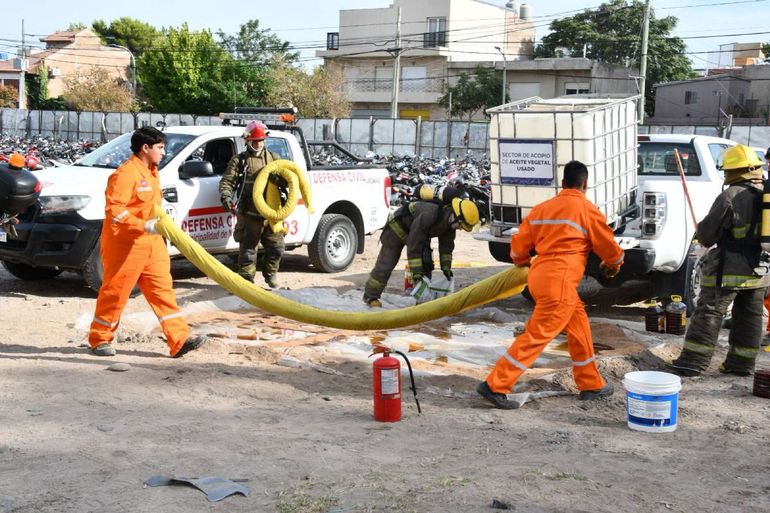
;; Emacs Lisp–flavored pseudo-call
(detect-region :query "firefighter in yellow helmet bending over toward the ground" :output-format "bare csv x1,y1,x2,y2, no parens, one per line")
364,198,479,307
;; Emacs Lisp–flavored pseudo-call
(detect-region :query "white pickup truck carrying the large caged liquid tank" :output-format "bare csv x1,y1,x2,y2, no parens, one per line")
476,134,736,312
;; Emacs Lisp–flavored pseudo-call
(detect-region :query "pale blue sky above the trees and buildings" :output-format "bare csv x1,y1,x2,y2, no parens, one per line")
0,0,770,68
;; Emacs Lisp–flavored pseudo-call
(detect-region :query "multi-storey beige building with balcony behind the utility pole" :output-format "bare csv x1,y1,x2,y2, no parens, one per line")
317,0,535,119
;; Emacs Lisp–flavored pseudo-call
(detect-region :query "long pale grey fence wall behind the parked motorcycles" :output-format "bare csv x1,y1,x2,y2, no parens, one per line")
0,109,770,158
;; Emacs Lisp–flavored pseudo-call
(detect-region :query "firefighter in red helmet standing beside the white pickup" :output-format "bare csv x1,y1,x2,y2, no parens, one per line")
219,121,288,288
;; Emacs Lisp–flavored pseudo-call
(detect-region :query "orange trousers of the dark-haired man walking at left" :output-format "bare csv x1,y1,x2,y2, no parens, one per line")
88,235,190,356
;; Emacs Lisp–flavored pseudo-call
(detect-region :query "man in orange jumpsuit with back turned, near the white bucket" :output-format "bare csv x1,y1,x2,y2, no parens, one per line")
476,161,624,410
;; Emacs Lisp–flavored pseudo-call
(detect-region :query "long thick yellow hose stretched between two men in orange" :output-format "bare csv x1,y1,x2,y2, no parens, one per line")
155,206,528,330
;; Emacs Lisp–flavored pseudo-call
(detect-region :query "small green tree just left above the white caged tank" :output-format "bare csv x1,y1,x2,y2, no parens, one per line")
439,65,503,121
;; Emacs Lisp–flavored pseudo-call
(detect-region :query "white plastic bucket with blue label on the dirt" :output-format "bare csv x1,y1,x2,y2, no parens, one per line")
623,371,682,433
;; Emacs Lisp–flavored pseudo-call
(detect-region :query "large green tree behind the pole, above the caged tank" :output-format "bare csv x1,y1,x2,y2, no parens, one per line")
535,0,694,113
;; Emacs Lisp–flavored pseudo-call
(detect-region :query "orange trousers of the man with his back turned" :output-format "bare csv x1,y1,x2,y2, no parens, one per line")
487,254,605,394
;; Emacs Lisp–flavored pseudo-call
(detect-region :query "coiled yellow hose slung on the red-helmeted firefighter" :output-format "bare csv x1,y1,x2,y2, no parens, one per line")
252,159,313,233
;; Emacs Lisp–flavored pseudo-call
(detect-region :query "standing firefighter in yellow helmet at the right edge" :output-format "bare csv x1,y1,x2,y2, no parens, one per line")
671,144,770,376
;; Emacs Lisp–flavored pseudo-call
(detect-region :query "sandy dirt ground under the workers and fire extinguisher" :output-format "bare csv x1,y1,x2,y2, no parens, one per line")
0,234,770,513
